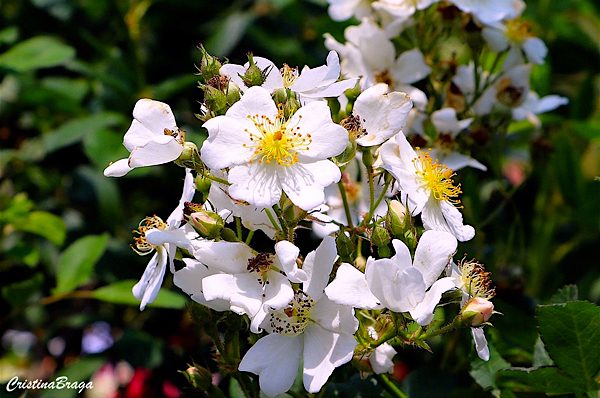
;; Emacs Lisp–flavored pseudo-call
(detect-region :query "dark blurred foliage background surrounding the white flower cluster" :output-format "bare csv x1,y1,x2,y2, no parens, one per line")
0,0,600,397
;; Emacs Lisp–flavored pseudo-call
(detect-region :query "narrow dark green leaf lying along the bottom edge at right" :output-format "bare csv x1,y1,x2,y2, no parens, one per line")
496,367,585,394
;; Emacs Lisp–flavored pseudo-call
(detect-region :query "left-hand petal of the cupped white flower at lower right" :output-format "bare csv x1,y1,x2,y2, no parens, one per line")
325,263,381,309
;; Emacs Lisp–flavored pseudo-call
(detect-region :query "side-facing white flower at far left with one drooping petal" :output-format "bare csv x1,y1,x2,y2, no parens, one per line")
104,99,185,177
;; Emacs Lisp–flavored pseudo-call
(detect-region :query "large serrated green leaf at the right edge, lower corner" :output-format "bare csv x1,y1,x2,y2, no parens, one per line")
537,301,600,391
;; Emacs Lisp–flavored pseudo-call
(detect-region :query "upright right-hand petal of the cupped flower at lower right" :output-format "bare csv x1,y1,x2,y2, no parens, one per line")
413,230,458,287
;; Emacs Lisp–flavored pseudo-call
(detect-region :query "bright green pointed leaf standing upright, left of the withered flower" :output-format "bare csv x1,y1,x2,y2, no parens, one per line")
53,234,108,294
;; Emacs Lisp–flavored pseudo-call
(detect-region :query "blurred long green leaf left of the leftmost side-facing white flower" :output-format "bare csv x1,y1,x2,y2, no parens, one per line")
42,112,125,153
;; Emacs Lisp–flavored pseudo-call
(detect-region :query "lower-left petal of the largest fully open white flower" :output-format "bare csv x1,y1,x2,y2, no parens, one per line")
228,162,282,207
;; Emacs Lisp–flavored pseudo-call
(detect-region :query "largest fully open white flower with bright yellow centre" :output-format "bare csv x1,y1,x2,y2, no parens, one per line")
201,87,348,210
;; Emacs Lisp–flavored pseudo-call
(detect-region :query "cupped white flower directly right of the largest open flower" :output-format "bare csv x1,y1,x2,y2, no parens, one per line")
352,83,412,146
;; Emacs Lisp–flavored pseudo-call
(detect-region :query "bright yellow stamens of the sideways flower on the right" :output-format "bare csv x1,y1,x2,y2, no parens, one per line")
413,149,462,205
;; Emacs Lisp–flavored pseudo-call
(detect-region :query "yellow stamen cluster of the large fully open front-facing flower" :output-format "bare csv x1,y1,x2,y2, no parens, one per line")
244,114,312,166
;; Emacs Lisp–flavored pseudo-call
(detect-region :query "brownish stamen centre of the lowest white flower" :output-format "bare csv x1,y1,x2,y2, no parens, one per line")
269,291,315,336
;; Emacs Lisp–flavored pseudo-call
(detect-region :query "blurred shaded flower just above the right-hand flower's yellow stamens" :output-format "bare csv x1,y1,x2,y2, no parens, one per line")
431,108,487,171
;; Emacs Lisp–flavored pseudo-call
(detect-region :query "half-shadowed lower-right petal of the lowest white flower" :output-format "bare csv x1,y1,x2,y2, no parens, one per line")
304,326,356,393
